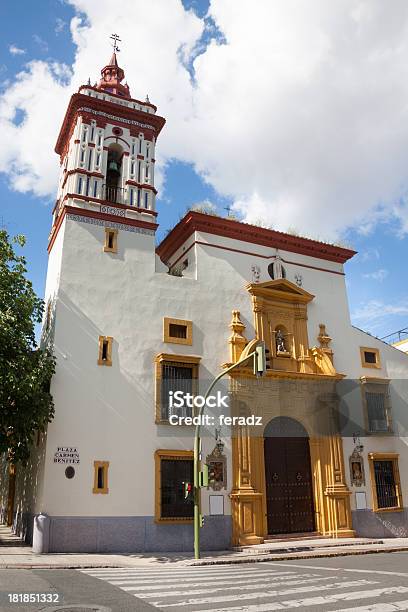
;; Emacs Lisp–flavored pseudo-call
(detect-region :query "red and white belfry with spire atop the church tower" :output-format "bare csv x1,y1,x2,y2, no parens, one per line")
48,34,165,251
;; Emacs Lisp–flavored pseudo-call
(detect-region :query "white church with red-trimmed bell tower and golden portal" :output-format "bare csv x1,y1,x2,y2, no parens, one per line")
1,49,408,552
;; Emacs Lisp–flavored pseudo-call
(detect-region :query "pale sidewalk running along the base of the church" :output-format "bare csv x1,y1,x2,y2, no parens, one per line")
0,526,408,569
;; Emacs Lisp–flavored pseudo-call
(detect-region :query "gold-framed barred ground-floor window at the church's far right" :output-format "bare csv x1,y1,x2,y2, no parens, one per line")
368,453,404,512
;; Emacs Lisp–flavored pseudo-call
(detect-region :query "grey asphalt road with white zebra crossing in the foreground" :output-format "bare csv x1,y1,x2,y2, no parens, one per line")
0,553,408,612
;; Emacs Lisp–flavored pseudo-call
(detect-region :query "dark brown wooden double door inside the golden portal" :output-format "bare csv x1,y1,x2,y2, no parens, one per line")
264,436,315,535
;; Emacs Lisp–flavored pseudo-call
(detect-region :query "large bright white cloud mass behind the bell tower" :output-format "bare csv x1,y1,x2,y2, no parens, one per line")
0,0,408,239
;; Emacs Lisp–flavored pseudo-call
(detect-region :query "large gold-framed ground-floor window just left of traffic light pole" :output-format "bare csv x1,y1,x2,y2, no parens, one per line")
154,449,194,523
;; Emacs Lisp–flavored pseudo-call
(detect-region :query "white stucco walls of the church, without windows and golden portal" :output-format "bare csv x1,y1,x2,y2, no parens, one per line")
3,52,408,551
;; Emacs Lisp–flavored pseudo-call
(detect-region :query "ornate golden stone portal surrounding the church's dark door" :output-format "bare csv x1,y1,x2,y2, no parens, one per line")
229,279,355,545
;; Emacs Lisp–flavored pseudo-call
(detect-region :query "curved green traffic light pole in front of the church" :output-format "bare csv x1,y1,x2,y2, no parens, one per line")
194,340,266,559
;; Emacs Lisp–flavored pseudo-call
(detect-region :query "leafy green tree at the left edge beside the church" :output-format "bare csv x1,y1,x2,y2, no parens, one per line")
0,230,55,465
